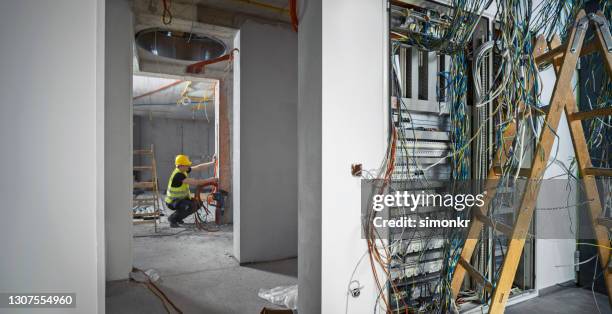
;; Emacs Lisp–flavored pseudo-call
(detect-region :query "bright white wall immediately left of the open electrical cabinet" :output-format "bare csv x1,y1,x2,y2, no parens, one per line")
320,0,388,313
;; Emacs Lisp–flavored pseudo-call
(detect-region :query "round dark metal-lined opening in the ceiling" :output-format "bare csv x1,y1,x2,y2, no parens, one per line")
136,28,227,62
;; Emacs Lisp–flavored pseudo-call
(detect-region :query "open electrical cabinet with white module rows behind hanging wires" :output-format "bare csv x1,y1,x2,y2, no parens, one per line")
388,1,491,312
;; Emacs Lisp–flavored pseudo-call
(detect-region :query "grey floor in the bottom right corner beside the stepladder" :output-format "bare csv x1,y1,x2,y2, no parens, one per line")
506,287,612,314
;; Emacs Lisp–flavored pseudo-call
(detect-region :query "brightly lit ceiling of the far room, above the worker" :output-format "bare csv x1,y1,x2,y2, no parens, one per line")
132,75,217,122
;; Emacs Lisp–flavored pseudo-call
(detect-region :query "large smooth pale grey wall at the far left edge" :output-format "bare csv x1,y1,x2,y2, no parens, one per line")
0,0,105,313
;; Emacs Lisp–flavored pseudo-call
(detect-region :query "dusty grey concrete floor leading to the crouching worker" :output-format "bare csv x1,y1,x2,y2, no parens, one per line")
106,219,297,314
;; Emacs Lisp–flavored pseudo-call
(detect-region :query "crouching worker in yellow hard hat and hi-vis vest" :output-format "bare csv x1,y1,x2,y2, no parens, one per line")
165,155,217,228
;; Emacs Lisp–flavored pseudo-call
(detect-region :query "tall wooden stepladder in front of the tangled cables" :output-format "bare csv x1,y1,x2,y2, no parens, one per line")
451,10,612,314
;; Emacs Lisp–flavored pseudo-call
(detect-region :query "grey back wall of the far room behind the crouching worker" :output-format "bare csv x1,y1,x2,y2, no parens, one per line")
134,116,215,189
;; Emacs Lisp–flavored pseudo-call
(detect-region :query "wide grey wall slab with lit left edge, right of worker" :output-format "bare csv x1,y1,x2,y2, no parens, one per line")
233,21,297,263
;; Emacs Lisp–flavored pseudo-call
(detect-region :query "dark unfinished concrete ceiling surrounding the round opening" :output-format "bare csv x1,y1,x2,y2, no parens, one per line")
133,0,290,79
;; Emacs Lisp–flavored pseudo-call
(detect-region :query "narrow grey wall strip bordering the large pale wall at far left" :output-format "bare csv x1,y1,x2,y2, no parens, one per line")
104,0,133,280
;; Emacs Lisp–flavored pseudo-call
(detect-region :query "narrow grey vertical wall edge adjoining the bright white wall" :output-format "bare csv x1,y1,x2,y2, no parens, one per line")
297,0,323,313
